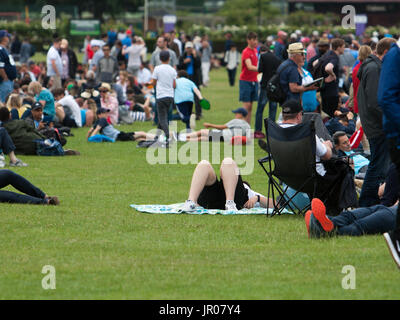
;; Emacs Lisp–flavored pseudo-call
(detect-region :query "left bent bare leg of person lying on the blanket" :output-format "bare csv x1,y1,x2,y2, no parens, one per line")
188,160,217,203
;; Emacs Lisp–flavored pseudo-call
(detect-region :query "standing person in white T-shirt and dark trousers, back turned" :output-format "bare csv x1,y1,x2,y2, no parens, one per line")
149,50,177,145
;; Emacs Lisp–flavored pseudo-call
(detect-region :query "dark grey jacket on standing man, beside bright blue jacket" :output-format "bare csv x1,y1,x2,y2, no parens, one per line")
357,54,384,139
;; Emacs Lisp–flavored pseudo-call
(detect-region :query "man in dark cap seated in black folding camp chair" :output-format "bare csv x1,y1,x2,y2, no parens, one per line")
259,100,355,215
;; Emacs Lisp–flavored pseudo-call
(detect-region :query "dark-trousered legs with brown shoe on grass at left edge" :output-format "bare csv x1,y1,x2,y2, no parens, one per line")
0,169,60,205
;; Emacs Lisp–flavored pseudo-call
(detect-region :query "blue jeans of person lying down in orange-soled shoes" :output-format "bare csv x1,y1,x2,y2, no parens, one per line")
329,205,397,236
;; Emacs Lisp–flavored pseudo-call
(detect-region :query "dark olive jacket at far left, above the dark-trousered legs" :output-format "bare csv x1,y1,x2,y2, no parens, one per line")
3,120,46,155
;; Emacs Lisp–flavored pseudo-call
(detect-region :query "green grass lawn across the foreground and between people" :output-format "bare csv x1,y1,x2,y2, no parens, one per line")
0,65,400,299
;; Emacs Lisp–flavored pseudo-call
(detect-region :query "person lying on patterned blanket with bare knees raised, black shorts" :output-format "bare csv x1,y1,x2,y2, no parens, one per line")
182,158,271,212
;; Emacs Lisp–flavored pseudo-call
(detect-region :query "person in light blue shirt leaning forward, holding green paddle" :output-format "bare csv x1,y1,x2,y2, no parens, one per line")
174,70,203,130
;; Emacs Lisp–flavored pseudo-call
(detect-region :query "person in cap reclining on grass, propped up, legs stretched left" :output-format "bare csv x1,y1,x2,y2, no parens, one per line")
178,108,251,141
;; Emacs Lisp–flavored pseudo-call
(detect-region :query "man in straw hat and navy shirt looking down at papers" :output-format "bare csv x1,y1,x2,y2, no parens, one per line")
274,42,318,104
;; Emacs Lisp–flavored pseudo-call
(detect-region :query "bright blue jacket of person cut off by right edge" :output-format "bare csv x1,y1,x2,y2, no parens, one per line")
378,43,400,146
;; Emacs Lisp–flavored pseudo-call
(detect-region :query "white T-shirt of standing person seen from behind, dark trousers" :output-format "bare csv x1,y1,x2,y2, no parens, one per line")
152,64,177,99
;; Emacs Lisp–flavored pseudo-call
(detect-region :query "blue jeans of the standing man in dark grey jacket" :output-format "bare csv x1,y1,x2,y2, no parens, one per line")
359,135,390,207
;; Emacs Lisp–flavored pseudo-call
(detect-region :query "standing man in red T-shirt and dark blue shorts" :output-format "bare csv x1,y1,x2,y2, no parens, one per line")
239,32,258,124
